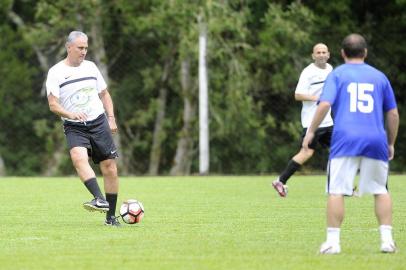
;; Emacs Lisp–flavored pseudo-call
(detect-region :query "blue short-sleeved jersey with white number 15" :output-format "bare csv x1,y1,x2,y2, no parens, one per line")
320,63,396,161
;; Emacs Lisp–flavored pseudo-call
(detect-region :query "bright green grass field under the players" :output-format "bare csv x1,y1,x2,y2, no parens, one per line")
0,176,406,270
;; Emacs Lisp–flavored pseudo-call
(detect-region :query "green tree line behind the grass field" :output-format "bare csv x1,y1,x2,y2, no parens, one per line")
0,0,406,176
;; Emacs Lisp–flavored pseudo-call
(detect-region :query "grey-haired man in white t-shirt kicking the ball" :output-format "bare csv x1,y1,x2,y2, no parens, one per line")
46,31,120,226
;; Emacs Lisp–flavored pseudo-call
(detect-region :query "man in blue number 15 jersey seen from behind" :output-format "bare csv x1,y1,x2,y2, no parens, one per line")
303,34,399,254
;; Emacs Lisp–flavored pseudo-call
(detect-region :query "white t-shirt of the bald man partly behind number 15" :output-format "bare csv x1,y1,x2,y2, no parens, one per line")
295,63,333,128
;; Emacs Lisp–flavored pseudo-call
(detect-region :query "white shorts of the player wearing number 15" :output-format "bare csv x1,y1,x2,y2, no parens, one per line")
326,157,389,196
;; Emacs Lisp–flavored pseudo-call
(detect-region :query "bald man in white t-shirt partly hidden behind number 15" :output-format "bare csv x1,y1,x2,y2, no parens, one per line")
272,43,333,197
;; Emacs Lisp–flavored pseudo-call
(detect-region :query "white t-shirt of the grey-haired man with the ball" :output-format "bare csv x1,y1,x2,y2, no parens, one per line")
46,60,107,122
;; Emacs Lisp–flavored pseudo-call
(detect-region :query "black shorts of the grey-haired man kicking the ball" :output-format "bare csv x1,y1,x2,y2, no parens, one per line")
63,114,118,164
